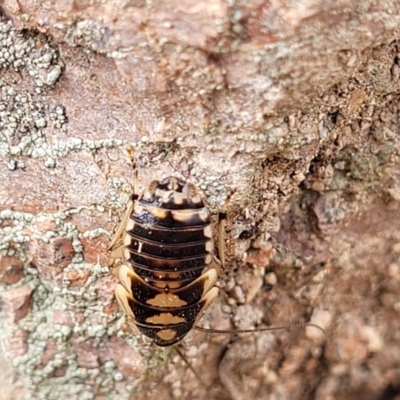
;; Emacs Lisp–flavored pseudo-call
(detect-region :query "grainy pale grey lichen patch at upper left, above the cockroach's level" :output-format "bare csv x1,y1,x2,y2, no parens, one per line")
0,19,136,170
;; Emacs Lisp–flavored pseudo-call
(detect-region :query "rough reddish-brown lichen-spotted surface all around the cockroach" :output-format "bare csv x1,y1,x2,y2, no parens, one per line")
0,0,400,400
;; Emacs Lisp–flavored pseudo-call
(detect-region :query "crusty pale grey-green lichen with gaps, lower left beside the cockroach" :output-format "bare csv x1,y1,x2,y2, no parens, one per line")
0,206,155,399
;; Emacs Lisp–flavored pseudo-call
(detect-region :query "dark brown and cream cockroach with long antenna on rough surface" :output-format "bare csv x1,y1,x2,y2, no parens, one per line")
108,177,322,346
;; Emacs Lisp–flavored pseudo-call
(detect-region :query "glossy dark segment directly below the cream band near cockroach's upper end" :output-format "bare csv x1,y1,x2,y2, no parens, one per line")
127,224,208,244
